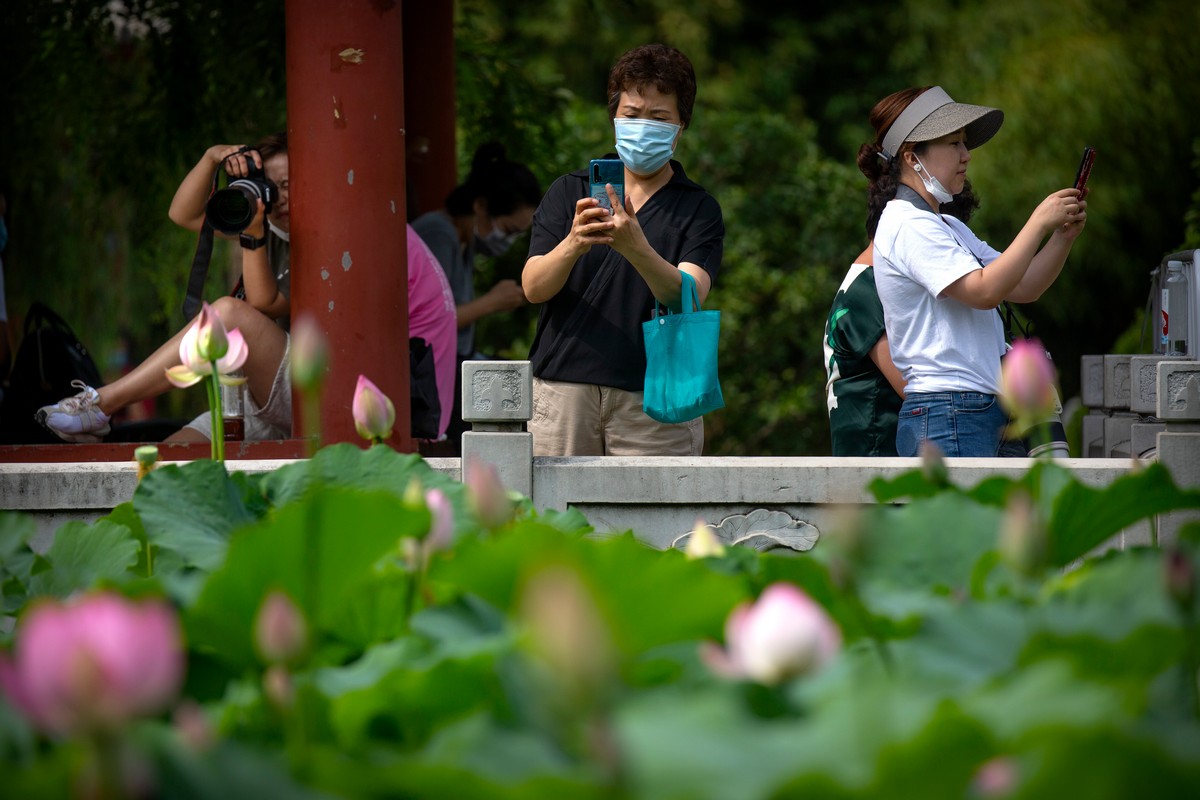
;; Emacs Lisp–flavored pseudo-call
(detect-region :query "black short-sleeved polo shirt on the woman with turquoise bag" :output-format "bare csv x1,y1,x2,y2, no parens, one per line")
529,155,725,392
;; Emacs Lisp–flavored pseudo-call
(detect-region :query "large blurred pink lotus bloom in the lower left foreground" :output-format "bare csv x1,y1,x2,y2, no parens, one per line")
0,594,184,735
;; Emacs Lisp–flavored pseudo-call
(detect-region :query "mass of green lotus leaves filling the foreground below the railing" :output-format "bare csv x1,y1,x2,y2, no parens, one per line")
7,444,1200,800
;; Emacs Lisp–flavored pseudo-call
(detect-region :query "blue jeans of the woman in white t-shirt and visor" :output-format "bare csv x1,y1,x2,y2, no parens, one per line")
896,392,1008,458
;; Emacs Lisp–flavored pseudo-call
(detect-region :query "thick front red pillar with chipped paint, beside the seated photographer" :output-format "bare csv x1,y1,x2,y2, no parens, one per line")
286,0,416,451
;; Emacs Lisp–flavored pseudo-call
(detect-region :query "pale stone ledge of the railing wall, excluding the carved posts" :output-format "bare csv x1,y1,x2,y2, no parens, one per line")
0,455,1146,556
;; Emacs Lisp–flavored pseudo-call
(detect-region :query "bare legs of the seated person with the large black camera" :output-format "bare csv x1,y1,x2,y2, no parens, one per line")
97,296,287,416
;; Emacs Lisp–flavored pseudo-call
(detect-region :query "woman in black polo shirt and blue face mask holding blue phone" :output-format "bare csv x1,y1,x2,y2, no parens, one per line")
521,44,725,456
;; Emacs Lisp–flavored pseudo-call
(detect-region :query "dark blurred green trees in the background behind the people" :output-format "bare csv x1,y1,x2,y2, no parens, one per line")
0,0,1200,455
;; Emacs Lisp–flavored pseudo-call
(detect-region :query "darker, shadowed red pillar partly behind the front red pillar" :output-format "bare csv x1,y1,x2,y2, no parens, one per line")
404,0,458,217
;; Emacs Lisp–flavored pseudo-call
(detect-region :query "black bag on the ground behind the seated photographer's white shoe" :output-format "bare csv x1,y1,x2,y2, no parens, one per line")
0,302,101,444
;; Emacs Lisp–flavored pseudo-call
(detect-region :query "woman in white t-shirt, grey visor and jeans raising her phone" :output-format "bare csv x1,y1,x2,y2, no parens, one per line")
859,86,1087,457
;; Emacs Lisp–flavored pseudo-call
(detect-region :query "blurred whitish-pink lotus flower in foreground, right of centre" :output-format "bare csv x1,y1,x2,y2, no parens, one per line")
701,583,841,685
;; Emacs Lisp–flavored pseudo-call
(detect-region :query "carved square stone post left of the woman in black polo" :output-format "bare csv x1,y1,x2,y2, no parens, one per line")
461,361,533,497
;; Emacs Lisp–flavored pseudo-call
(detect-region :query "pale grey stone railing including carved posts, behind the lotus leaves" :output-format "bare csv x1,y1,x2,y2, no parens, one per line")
0,361,1200,551
